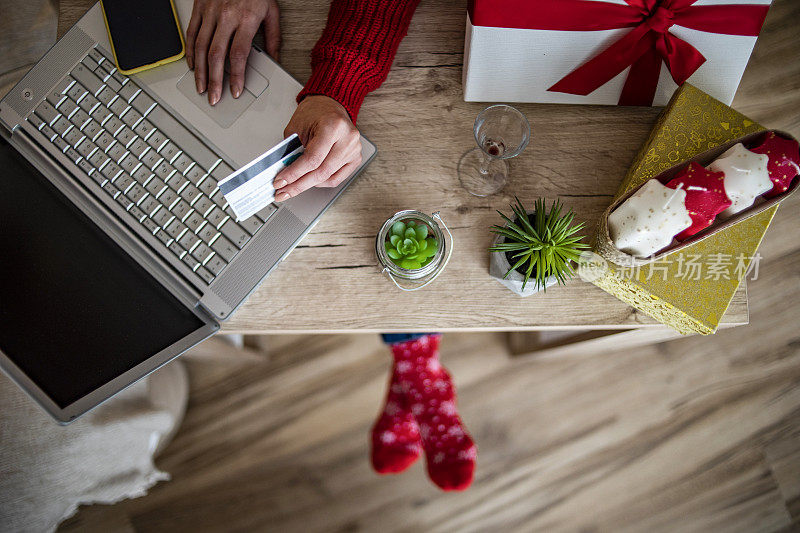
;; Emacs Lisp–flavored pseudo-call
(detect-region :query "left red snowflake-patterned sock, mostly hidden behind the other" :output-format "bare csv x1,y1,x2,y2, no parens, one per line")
371,364,422,474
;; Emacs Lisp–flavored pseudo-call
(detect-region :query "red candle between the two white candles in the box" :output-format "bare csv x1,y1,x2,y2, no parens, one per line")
667,162,731,241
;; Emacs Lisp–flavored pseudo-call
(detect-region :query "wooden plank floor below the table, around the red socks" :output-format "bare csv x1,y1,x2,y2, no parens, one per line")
64,189,800,532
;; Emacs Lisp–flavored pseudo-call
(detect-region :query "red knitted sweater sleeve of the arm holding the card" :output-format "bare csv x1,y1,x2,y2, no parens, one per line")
297,0,419,122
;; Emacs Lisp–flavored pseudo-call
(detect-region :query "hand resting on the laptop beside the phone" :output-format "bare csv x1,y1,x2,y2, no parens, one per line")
186,0,281,105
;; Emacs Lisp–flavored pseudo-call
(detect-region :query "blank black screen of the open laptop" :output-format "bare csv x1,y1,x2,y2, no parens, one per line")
0,140,204,408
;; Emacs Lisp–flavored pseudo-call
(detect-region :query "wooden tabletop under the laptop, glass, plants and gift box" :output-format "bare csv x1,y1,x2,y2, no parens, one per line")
59,0,800,333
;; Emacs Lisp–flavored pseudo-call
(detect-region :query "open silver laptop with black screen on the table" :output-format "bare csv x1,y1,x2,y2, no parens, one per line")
0,0,376,423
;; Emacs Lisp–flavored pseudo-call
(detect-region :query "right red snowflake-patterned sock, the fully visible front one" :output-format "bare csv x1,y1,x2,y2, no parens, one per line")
392,335,477,490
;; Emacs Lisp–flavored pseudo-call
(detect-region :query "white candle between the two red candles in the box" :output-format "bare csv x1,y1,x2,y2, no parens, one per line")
708,143,772,217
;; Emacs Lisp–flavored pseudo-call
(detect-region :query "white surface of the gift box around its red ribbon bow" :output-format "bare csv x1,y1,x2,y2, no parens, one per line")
463,0,771,106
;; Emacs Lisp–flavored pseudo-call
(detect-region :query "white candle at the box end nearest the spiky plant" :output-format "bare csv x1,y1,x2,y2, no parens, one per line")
608,179,692,257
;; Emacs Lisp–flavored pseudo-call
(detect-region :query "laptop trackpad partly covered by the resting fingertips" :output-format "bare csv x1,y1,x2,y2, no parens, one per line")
178,67,269,128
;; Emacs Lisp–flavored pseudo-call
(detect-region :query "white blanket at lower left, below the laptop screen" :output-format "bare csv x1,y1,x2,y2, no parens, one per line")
0,361,187,532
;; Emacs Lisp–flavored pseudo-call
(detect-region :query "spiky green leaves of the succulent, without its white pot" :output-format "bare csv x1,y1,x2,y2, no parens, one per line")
489,198,588,290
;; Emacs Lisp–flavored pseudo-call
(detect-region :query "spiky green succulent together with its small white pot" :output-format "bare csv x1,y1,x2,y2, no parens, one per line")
489,198,588,296
